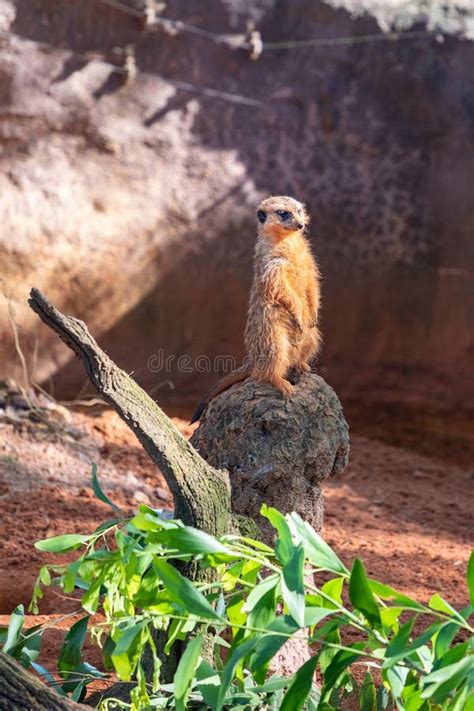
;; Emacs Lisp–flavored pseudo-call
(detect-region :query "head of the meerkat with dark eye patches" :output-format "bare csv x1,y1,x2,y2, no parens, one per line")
257,195,309,242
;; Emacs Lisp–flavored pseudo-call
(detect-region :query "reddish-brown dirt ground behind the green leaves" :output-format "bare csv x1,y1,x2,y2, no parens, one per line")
0,392,474,692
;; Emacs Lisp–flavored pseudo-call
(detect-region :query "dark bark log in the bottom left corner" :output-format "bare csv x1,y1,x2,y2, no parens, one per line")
0,652,92,711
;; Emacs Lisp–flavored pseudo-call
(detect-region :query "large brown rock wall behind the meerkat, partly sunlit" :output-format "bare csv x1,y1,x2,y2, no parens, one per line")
0,0,474,408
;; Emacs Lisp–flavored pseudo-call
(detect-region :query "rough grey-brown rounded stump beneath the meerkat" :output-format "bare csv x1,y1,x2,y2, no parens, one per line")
191,373,349,544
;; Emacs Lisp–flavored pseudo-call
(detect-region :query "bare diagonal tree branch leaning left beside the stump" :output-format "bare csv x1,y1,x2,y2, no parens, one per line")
28,289,231,536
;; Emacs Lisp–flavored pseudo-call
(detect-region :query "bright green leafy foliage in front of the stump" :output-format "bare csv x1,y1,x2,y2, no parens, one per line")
3,471,474,711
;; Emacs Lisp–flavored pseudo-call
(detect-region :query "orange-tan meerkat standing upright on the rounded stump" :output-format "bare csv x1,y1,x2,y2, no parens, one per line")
191,196,321,422
